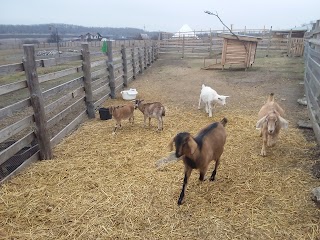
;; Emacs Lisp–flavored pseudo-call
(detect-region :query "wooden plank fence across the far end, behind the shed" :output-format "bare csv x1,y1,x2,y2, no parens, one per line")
159,29,304,58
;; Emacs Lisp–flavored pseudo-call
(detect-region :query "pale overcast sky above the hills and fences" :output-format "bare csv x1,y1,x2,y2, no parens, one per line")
0,0,320,32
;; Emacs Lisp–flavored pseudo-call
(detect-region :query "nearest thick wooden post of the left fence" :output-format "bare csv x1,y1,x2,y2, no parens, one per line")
23,44,53,160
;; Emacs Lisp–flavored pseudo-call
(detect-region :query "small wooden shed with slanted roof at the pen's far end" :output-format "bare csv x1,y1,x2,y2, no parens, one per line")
219,34,261,69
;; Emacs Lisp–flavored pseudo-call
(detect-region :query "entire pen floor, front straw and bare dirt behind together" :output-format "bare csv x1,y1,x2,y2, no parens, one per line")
0,27,320,239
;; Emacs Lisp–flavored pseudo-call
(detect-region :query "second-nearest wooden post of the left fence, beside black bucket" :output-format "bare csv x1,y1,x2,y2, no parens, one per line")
81,43,96,118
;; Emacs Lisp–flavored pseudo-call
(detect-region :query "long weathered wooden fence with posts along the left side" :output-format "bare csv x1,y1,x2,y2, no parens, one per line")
0,41,158,183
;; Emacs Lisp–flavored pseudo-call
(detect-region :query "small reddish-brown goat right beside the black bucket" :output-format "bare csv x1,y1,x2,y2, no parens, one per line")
109,103,134,134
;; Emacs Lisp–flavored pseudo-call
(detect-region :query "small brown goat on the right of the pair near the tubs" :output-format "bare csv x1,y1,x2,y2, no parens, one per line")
135,99,166,131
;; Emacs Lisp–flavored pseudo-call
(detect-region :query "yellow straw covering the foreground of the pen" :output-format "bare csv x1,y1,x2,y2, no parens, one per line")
0,105,320,240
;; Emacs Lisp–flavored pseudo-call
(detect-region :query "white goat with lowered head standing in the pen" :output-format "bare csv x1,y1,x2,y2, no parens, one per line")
198,84,229,117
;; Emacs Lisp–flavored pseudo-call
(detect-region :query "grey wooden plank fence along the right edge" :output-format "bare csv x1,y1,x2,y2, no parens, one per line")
304,20,320,144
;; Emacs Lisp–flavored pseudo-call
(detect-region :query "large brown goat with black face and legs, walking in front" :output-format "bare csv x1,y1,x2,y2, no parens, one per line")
169,118,227,205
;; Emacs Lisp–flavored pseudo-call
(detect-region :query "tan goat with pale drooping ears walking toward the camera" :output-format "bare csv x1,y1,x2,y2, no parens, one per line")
256,93,288,156
